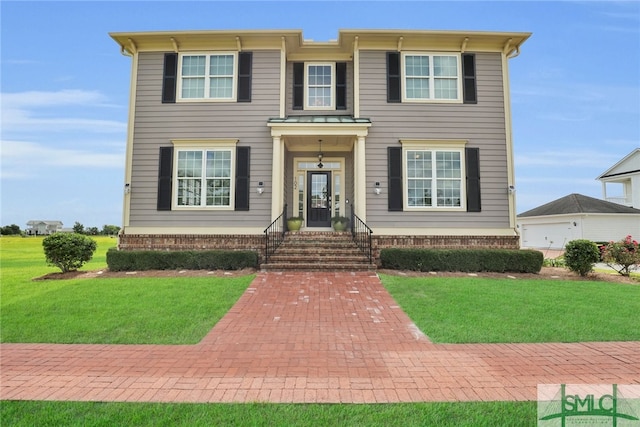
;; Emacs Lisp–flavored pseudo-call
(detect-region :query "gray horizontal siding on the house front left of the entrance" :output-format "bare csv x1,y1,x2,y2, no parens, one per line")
130,51,280,227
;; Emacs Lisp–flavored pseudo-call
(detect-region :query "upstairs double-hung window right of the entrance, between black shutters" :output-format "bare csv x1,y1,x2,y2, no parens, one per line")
402,53,462,102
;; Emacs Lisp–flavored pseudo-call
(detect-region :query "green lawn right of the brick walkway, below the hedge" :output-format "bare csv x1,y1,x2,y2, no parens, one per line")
380,275,640,343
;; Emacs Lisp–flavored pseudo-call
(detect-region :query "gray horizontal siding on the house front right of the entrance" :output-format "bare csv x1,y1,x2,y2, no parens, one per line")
360,51,509,231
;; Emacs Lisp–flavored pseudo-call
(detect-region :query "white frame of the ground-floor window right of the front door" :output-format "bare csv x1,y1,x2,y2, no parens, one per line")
400,140,467,212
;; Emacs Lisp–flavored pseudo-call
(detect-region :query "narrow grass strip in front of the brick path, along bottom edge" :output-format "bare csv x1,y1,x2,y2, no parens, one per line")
0,401,537,427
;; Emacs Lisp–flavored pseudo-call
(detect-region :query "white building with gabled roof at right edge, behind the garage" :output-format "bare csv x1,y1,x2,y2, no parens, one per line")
597,148,640,209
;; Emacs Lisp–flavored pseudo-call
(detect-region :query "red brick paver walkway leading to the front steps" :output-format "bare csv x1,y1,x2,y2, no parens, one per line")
0,273,640,403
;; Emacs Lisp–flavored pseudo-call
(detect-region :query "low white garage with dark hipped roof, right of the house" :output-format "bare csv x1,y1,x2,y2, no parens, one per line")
518,194,640,249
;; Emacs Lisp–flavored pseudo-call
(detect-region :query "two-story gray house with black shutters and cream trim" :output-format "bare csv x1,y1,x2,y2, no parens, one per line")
111,30,530,262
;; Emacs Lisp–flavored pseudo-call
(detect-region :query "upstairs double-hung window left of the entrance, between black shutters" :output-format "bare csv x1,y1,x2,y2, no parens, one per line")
178,53,237,101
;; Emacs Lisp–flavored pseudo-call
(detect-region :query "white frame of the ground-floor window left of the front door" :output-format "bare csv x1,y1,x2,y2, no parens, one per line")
171,139,238,211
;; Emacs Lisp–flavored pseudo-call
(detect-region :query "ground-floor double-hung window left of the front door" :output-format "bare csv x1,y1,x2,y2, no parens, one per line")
176,148,233,208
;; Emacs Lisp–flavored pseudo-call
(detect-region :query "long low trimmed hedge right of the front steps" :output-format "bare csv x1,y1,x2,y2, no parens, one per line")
380,248,544,273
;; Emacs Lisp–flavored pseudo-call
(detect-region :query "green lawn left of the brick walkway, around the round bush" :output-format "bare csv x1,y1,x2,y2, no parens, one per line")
0,237,253,344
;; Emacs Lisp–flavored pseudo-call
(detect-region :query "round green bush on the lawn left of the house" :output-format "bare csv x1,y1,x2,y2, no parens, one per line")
42,233,98,273
